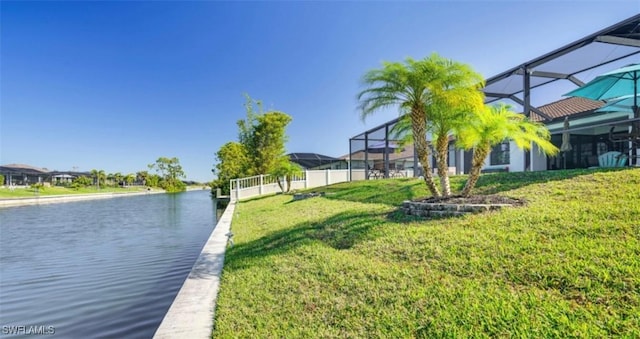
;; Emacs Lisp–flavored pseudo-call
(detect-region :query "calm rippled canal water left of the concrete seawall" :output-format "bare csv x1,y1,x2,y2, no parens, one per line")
0,191,216,338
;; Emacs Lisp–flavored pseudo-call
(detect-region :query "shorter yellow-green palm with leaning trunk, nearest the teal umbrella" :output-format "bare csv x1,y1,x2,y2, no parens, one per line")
457,104,558,197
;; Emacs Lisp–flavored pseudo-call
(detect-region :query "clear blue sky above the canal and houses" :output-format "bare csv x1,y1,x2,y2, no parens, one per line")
0,0,640,181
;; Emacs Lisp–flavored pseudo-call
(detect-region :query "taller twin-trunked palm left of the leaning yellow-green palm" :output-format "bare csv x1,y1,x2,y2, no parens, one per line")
358,53,483,196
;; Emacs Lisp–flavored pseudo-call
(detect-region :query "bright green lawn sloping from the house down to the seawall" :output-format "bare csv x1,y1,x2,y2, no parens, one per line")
213,169,640,338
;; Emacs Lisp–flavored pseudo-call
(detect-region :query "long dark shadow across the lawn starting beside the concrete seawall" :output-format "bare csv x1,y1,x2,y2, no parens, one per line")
225,211,385,269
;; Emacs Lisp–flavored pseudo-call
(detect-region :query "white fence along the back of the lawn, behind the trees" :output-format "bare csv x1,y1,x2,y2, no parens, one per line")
230,169,350,201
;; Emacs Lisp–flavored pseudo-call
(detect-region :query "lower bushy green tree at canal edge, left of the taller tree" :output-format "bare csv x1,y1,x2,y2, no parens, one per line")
211,141,253,194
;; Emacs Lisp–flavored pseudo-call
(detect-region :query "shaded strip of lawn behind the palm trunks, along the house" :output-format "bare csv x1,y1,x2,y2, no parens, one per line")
309,167,629,206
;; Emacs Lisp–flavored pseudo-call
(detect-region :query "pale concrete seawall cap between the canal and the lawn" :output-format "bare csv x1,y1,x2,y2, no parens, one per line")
153,202,235,339
